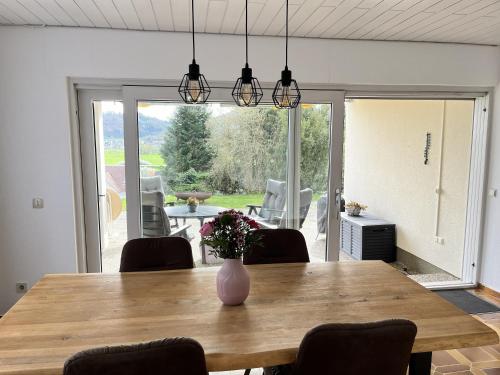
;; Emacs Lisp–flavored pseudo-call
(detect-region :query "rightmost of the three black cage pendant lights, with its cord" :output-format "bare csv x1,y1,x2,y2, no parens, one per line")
273,0,300,108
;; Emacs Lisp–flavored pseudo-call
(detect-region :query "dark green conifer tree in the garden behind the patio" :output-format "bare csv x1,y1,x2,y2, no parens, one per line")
161,106,214,188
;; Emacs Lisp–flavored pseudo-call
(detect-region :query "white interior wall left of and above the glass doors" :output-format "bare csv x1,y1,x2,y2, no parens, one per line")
0,27,500,313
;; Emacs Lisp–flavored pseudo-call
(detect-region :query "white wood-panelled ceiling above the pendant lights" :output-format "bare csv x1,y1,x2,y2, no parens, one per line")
0,0,500,45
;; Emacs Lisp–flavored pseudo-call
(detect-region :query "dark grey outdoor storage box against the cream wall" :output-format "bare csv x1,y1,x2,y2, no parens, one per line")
340,212,396,262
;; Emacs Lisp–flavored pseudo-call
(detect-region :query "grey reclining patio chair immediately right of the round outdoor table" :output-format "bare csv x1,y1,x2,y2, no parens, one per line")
247,179,286,222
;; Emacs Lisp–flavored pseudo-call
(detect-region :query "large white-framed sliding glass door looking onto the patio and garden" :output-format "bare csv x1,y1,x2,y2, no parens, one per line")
79,86,344,272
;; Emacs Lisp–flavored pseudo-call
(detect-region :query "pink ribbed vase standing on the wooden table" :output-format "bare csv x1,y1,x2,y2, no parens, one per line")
217,259,250,305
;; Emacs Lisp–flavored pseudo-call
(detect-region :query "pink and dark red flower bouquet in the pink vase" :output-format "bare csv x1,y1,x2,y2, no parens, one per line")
200,210,260,259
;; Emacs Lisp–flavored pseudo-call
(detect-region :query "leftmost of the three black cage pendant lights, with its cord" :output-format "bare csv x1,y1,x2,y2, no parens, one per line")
179,0,211,104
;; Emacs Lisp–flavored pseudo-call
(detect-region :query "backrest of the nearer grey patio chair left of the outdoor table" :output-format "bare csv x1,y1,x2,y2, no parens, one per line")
141,191,172,237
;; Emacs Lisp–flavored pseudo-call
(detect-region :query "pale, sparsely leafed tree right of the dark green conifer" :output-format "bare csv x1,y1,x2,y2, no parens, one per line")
208,106,287,193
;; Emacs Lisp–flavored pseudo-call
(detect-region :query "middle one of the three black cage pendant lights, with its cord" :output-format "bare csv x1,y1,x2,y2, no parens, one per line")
232,0,264,107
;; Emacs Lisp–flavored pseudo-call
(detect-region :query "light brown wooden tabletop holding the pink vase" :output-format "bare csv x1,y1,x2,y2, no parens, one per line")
0,261,498,375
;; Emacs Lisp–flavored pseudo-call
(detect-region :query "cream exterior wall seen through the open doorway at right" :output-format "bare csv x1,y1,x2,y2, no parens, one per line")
344,99,474,278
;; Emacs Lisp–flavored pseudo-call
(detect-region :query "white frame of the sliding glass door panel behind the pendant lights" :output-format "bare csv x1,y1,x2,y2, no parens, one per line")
123,83,345,261
